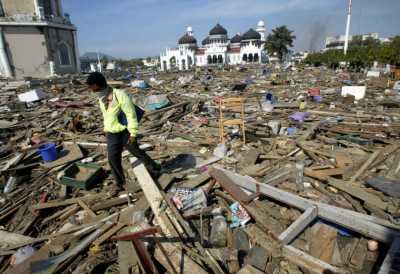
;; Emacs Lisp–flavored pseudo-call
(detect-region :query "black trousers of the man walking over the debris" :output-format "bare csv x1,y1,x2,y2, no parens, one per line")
106,130,160,187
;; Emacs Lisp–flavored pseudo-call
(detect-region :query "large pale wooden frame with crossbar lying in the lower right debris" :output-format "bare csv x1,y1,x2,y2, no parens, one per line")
214,167,400,274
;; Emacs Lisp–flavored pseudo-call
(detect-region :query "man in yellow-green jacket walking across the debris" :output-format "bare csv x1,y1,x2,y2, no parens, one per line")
86,72,160,192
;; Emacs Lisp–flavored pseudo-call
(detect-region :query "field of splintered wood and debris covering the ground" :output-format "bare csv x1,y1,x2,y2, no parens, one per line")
0,66,400,274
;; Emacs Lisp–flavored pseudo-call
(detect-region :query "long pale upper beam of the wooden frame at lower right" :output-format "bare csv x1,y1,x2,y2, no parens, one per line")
214,166,400,243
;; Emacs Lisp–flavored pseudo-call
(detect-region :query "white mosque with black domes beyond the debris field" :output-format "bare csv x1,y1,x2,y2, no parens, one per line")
160,21,267,71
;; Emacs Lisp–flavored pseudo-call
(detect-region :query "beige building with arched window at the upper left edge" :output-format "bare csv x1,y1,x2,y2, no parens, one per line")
0,0,80,79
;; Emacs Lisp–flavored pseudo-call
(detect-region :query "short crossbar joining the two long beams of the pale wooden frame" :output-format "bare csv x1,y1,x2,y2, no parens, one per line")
279,206,318,245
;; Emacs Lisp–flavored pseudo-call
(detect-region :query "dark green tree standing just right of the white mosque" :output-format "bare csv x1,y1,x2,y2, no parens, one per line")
265,26,296,62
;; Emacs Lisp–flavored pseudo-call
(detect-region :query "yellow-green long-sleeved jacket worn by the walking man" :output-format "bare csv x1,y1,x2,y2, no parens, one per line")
99,88,139,137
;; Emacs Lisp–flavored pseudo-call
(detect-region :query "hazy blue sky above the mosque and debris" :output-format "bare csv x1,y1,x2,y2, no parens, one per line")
63,0,400,58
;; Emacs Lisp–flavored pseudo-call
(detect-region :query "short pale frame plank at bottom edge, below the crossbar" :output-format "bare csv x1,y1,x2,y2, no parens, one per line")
283,245,350,274
